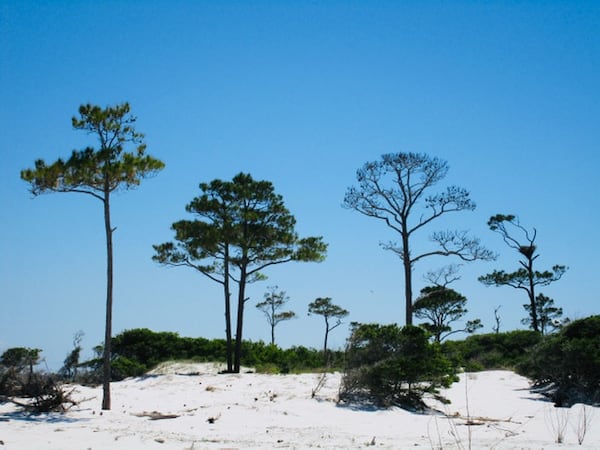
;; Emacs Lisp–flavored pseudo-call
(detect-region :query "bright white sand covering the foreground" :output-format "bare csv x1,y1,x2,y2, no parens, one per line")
0,364,600,450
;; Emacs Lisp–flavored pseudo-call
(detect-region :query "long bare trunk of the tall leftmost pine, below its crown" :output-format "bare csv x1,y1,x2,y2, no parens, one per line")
102,191,113,410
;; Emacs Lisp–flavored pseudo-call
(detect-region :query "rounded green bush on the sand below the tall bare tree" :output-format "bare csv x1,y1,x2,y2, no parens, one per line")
340,323,457,409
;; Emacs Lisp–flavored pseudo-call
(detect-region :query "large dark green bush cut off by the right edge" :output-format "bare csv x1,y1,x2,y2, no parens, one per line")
520,316,600,406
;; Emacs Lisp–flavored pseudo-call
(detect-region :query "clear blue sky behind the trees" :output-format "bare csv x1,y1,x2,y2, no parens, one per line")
0,0,600,369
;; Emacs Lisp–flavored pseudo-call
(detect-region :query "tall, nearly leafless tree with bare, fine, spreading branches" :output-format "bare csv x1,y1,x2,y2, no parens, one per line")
343,153,494,325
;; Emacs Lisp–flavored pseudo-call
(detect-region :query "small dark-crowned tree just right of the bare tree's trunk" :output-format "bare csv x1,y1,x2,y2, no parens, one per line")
413,286,483,343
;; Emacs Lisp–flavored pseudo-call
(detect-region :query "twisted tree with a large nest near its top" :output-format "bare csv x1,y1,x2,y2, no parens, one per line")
479,214,567,332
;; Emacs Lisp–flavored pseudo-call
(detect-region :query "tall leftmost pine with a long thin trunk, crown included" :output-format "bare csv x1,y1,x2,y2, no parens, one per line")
21,103,164,409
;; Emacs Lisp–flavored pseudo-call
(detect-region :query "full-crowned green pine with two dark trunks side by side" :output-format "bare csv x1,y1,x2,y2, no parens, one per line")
153,173,327,372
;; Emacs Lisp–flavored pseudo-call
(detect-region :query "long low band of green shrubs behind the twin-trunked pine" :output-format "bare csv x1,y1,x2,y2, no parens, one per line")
106,328,343,380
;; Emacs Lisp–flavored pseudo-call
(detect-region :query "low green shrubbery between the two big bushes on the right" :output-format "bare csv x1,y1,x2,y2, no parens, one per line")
442,330,542,372
